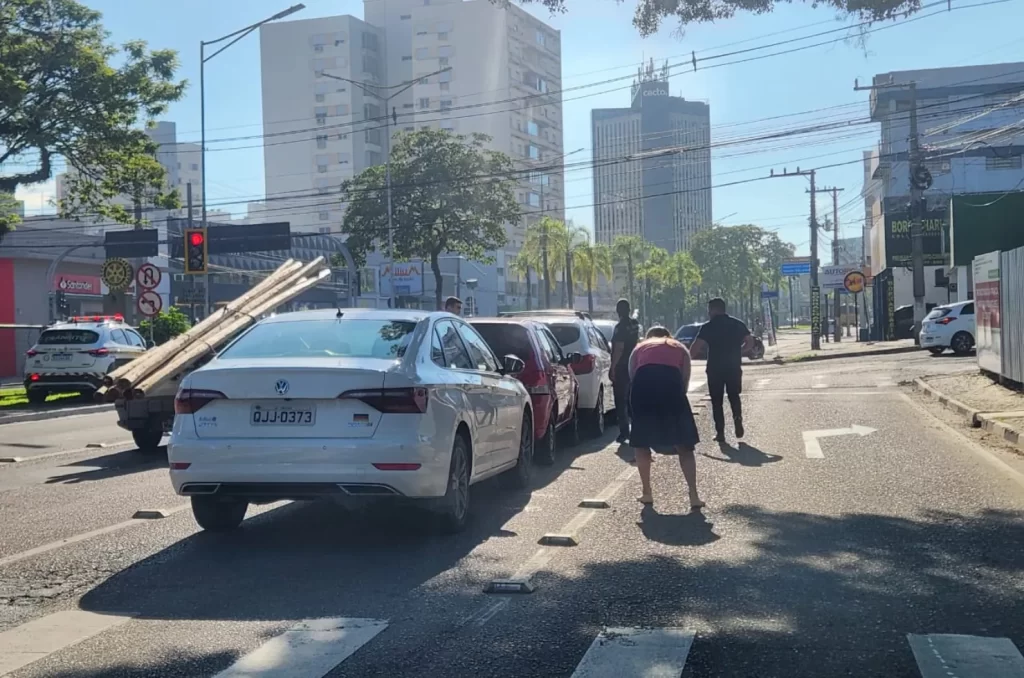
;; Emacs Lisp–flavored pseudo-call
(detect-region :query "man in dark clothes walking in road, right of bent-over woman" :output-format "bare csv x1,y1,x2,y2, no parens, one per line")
690,297,754,442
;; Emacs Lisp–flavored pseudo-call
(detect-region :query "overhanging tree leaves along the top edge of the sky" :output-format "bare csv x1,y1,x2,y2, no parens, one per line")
503,0,921,37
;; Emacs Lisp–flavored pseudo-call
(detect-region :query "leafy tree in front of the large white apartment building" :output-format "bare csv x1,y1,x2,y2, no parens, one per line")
341,129,520,308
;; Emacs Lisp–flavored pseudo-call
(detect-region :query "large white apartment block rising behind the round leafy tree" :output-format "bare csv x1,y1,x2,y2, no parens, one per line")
260,0,564,313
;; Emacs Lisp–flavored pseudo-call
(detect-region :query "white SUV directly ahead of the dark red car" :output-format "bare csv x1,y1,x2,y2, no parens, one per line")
501,309,610,437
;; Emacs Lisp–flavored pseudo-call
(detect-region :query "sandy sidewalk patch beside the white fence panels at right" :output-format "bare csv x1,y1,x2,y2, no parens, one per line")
914,372,1024,453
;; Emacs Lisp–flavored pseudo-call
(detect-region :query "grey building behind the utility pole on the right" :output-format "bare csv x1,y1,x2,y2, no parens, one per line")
864,62,1024,306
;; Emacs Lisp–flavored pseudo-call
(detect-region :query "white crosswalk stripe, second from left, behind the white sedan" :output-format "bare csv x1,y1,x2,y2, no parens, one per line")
214,617,388,678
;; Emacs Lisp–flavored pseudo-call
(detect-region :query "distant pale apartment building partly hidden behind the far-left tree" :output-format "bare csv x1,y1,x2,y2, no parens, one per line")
56,121,203,235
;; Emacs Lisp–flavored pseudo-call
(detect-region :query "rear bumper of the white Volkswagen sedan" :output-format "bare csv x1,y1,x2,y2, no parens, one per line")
167,435,452,501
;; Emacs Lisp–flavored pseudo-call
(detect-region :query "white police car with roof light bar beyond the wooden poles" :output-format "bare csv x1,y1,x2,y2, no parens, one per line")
25,315,146,405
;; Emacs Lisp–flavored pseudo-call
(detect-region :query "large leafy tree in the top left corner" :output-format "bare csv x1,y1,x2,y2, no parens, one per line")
0,0,185,194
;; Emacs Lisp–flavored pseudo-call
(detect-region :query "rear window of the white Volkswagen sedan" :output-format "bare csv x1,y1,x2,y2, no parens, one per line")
220,319,416,359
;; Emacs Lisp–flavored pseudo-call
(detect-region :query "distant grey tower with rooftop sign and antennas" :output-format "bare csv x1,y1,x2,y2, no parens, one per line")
591,66,712,252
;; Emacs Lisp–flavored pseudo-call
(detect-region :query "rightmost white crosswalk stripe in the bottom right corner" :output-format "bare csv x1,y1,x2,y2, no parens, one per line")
907,633,1024,678
